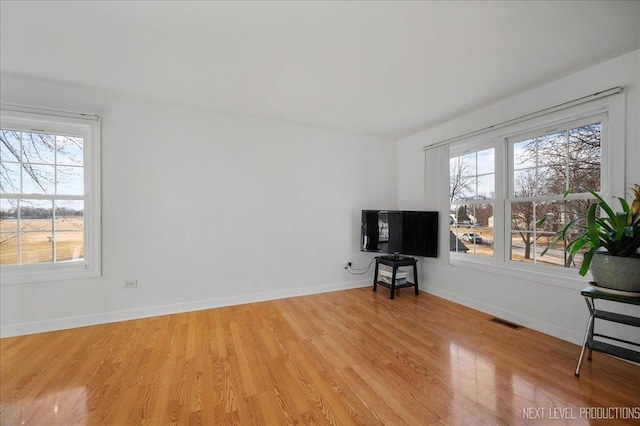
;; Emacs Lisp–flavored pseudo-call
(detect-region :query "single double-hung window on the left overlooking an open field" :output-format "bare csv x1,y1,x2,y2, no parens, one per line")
0,109,100,284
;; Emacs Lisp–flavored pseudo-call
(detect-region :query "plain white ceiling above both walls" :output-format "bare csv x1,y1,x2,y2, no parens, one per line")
0,0,640,139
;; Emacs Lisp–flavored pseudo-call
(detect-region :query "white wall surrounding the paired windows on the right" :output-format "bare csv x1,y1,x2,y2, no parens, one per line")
398,50,640,343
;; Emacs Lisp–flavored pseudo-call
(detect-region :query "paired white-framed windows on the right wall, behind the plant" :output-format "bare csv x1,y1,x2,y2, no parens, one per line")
443,90,625,282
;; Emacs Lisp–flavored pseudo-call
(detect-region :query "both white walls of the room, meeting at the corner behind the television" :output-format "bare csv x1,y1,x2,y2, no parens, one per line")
0,51,640,343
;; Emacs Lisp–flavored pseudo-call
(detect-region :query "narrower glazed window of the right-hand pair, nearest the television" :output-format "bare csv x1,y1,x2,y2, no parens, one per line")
449,147,496,257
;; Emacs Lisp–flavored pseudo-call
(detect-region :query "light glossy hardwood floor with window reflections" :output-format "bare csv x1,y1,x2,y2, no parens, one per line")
0,288,640,426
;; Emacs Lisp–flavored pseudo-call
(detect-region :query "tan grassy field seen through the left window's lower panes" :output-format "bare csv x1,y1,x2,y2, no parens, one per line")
0,217,84,265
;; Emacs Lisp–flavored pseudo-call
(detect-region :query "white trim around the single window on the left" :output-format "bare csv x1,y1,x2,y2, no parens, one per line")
0,108,101,286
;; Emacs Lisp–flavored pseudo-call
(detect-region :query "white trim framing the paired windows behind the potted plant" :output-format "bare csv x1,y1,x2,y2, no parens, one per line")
441,91,626,288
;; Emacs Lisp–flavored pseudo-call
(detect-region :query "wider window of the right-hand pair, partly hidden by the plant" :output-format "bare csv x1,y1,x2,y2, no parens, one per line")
506,115,606,267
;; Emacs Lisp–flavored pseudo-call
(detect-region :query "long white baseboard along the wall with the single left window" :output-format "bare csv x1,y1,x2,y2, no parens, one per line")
0,279,371,338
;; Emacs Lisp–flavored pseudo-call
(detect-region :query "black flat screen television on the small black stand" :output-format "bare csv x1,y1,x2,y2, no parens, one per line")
360,210,438,257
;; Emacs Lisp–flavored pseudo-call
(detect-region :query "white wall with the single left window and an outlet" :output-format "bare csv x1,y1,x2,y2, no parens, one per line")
0,74,396,336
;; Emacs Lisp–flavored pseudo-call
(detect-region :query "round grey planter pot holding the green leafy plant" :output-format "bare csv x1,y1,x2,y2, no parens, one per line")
589,252,640,293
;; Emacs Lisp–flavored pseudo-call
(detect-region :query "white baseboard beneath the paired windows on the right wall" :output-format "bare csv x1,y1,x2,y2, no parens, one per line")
423,286,584,345
